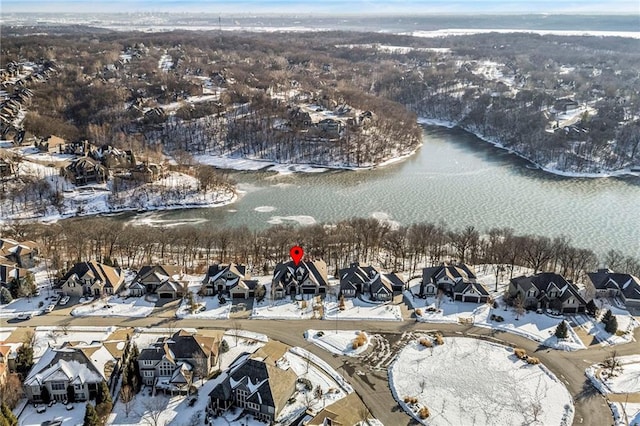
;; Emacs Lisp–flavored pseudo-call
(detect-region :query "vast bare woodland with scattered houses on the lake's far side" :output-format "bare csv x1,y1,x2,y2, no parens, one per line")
0,27,640,172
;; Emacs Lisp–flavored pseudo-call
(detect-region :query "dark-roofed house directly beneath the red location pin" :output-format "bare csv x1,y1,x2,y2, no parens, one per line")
271,260,328,299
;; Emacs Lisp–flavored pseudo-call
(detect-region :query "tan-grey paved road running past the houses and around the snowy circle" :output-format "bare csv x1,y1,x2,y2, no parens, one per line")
0,307,640,426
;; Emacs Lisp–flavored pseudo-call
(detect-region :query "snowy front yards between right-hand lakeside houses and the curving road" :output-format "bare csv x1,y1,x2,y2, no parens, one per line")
405,289,585,351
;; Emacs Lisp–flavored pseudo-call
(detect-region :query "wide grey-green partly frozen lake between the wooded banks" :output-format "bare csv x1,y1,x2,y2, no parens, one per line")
128,126,640,257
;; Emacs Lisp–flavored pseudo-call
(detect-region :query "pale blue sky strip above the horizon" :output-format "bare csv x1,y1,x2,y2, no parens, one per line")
0,0,640,17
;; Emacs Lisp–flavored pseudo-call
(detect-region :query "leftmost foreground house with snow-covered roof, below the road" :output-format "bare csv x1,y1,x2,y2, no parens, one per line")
23,344,118,403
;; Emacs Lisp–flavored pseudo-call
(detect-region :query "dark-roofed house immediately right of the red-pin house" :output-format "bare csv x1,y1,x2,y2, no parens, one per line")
338,263,404,301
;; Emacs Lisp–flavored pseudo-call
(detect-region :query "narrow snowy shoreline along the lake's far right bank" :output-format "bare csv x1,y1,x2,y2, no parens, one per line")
418,117,640,179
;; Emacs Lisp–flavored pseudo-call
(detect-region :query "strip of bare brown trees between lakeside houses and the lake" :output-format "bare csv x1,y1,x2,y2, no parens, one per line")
7,218,640,290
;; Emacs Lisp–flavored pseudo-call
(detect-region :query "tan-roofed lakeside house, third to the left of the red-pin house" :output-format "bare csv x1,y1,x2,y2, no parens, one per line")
58,260,124,297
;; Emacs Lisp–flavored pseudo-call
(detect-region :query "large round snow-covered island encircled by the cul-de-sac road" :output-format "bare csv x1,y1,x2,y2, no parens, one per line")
389,337,574,426
